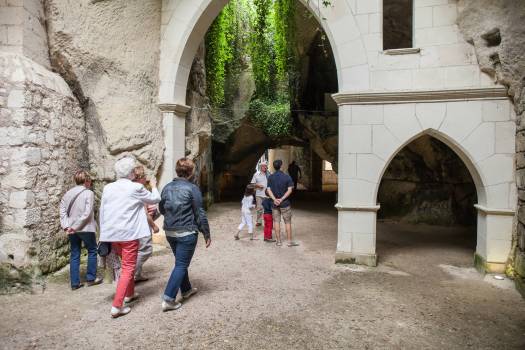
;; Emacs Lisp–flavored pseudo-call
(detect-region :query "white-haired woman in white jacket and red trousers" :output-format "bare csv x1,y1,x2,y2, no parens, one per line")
100,157,160,318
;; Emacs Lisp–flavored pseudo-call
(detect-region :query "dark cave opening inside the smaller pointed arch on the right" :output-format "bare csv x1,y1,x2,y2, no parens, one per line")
377,135,478,265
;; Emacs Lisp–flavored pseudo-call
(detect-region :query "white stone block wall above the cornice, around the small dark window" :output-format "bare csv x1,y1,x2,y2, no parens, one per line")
340,0,494,91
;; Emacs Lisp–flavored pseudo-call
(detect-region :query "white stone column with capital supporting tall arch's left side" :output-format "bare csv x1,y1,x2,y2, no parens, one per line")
158,103,191,187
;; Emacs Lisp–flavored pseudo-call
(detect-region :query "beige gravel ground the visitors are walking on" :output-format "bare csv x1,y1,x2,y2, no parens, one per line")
0,197,525,349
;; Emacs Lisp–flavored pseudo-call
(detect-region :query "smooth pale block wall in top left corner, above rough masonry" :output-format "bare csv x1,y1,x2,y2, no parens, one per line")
0,0,50,68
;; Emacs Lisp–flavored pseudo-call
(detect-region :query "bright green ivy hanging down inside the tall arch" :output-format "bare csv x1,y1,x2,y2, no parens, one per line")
205,0,330,137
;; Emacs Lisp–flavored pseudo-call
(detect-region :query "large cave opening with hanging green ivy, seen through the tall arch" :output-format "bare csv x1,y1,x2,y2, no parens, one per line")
186,0,338,204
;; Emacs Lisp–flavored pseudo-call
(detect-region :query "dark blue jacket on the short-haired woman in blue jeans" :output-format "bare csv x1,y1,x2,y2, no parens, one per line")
159,178,210,239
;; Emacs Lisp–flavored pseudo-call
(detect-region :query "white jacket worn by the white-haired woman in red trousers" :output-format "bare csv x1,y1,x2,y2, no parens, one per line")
100,179,160,242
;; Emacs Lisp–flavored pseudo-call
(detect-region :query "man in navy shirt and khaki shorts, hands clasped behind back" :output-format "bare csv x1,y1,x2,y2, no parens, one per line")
268,159,299,247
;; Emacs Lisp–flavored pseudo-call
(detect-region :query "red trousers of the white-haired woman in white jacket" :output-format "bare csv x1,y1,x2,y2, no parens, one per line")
111,240,139,308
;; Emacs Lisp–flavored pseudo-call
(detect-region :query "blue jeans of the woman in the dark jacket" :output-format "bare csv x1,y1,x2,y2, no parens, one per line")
163,233,197,301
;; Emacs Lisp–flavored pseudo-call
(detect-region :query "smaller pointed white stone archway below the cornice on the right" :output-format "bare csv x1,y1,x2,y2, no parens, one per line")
335,90,516,271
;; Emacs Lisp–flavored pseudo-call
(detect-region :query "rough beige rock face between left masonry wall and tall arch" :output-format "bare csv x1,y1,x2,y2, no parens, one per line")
46,0,164,181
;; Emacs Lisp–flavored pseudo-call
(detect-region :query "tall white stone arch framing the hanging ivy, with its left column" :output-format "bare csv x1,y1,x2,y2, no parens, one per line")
159,0,369,184
